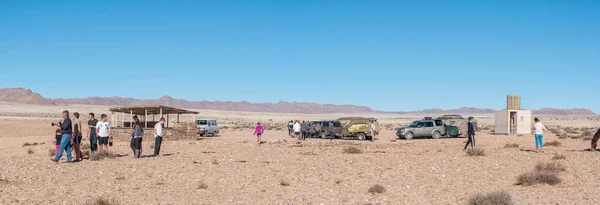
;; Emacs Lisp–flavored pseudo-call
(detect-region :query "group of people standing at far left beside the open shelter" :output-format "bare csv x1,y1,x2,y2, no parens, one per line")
52,110,165,162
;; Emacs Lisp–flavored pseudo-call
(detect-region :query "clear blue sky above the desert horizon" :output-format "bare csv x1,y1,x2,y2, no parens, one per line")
0,0,600,113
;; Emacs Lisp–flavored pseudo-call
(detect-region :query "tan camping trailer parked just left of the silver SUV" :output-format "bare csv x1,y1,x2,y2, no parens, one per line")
338,117,380,140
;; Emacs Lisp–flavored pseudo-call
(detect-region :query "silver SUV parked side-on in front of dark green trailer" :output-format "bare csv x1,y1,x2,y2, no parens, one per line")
396,120,446,140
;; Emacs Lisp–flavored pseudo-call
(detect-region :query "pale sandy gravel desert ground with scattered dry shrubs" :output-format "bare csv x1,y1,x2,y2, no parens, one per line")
0,103,600,204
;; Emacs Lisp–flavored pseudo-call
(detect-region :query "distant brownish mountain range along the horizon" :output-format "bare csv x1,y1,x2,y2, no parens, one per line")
0,88,596,115
